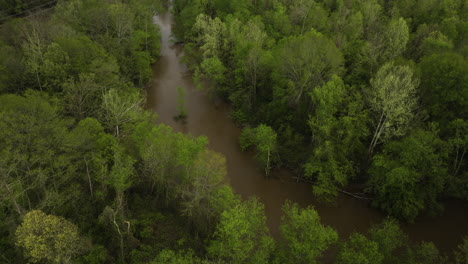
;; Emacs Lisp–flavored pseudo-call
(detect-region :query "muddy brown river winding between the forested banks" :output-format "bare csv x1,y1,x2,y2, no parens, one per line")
147,10,468,258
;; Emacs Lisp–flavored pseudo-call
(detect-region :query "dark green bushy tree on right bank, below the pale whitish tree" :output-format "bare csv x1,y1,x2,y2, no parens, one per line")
369,129,447,221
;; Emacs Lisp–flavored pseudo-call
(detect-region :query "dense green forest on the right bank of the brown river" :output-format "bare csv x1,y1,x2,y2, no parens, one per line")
174,0,468,221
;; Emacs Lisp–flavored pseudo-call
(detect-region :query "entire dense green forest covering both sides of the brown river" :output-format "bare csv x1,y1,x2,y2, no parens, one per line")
0,0,468,264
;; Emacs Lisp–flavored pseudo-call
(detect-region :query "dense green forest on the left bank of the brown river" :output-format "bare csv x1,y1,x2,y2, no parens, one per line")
0,0,225,263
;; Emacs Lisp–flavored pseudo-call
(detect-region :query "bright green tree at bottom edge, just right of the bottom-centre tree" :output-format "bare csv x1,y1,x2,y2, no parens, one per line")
280,202,338,263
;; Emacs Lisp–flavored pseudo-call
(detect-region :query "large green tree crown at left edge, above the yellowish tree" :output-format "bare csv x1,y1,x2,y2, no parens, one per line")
0,92,74,215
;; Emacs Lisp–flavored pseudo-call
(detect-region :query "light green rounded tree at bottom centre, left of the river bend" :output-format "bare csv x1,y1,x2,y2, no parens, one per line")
207,199,274,264
